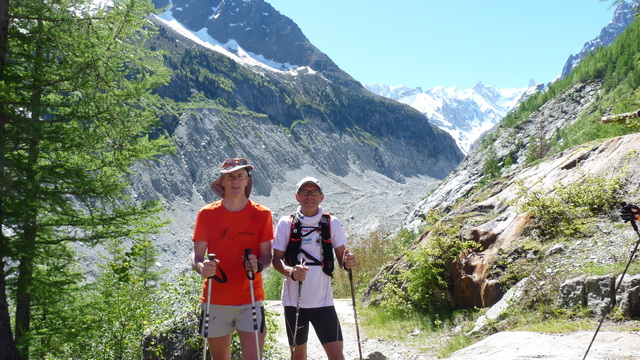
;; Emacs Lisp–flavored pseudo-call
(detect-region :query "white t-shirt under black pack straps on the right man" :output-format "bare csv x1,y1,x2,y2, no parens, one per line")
273,208,347,308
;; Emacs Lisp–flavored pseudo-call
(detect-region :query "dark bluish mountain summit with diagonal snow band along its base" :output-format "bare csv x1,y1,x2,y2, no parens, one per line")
153,0,357,84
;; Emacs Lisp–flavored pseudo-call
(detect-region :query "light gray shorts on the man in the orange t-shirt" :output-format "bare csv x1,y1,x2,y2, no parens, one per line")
199,301,265,338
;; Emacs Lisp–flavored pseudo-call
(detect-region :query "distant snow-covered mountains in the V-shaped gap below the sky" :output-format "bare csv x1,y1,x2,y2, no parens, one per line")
364,81,539,154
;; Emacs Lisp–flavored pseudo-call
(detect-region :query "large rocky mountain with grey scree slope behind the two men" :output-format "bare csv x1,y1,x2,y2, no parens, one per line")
117,0,464,274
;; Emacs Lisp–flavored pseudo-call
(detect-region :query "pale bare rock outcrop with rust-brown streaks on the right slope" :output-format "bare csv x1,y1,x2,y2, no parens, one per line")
365,134,640,307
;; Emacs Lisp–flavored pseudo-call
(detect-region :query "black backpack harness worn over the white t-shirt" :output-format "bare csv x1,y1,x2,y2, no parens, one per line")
284,211,334,277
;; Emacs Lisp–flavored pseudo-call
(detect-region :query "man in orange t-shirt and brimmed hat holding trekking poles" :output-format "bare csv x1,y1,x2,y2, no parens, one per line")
191,158,273,360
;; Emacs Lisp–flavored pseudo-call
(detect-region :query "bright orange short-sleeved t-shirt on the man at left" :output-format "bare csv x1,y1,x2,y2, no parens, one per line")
192,200,273,305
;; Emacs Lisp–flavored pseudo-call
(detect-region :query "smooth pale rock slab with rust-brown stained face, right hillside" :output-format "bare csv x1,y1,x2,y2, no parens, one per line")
450,134,640,307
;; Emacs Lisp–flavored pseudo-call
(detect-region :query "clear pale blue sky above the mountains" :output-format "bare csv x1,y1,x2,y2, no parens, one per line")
266,0,614,89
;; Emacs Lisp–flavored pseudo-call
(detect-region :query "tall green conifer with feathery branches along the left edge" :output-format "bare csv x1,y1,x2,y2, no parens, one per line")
0,0,169,359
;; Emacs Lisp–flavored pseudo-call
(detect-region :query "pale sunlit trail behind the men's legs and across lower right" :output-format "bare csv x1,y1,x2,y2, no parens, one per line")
266,299,640,360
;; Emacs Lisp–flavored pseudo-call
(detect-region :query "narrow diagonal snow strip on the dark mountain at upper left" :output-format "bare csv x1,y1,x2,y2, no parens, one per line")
153,5,316,76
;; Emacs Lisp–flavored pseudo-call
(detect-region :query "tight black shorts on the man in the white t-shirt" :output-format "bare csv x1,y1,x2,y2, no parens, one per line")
284,306,342,346
